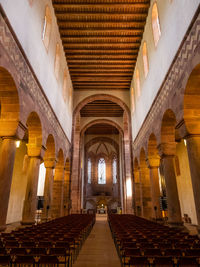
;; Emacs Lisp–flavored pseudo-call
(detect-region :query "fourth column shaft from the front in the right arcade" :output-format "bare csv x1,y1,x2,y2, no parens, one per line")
140,166,152,219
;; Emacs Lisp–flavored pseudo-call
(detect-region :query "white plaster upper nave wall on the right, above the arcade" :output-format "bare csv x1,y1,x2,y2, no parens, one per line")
130,0,200,141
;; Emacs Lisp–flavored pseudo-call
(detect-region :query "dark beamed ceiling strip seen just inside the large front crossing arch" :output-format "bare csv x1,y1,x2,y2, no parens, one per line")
80,100,124,117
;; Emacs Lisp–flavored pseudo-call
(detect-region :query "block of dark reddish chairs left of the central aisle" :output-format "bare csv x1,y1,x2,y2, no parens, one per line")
0,214,95,267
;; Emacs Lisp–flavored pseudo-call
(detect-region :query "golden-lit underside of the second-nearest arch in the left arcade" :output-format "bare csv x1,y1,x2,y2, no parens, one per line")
26,111,42,156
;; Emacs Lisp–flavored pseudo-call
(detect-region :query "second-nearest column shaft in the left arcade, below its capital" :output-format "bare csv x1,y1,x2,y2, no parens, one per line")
21,156,41,225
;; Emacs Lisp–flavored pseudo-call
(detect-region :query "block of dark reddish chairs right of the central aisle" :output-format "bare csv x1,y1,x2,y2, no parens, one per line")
108,214,200,267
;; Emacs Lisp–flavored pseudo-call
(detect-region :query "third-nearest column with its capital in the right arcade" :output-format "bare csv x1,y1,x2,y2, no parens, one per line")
148,158,162,219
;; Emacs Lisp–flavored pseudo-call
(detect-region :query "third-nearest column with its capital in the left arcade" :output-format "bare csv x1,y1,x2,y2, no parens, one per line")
42,159,56,221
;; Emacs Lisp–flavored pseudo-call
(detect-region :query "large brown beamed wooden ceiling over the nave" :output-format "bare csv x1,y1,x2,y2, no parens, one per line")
52,0,150,91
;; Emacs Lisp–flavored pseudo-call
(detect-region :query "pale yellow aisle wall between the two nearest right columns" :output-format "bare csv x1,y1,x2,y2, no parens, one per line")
176,140,197,224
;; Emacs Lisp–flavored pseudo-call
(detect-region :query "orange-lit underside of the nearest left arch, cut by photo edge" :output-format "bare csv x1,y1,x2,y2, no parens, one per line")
0,67,20,136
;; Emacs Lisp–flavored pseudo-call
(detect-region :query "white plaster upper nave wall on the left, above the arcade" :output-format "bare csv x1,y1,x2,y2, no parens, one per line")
0,0,72,140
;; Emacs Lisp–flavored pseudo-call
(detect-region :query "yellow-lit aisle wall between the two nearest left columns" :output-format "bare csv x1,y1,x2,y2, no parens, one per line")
6,142,27,224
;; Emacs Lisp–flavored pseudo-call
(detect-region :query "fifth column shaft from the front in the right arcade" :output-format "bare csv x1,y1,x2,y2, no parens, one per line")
134,170,143,216
